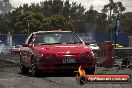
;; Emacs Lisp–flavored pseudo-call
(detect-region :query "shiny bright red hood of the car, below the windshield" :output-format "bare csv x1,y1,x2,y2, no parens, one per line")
34,44,92,54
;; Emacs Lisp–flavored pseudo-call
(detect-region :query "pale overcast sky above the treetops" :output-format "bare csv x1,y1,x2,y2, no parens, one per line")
10,0,132,12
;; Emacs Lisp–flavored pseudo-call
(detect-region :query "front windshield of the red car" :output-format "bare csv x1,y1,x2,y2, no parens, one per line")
34,32,82,44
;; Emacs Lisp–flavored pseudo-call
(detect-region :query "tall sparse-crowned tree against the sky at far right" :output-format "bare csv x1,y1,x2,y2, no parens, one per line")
102,2,126,32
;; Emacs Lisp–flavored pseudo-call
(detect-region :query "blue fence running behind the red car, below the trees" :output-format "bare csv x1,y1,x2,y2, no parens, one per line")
0,33,132,46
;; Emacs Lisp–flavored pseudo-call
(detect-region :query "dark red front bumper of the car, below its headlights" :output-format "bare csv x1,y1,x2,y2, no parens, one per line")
36,58,96,71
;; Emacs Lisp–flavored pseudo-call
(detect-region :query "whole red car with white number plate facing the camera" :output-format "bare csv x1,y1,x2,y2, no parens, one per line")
20,31,96,76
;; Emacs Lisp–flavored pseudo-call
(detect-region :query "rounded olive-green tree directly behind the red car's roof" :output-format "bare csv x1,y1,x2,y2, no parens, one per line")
41,15,73,31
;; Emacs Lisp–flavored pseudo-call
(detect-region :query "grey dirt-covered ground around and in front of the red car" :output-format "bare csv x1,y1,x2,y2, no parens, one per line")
0,55,132,88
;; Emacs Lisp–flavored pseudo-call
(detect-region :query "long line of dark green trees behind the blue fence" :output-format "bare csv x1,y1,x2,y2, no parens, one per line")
0,0,132,34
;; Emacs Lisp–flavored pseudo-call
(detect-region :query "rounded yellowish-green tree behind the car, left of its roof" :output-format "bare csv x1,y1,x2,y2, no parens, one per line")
14,11,44,33
